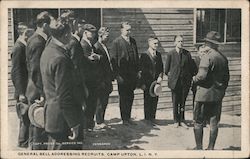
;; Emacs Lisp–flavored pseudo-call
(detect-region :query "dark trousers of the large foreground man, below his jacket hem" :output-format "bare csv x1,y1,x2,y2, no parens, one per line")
47,126,83,150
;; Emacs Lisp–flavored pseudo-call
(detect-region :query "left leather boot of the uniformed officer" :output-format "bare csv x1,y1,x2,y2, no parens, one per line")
194,124,203,150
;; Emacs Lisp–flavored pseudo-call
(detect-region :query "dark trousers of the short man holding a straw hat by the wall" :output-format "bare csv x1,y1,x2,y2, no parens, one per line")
144,87,158,120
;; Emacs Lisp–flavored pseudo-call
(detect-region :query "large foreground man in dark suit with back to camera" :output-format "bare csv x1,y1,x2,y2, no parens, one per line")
40,20,83,150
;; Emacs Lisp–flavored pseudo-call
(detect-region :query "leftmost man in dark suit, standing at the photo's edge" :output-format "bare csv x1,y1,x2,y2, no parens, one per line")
11,23,34,148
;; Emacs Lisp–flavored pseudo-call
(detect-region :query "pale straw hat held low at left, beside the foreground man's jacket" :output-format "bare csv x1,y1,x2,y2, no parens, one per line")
28,103,44,128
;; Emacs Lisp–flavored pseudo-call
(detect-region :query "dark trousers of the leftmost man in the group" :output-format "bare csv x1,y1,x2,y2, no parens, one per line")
18,112,30,147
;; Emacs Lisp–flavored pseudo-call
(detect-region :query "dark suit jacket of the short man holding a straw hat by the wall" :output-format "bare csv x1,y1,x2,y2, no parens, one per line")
140,51,163,87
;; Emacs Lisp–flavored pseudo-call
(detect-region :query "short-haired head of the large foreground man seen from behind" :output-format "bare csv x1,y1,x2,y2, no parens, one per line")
50,18,71,38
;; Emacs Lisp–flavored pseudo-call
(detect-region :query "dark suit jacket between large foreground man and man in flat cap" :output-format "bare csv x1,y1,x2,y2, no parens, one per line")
66,36,88,99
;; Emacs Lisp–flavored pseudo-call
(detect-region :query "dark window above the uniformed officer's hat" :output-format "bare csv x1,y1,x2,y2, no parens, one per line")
196,9,241,43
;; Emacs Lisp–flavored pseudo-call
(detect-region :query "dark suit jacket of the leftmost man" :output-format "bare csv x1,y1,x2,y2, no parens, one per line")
11,40,28,99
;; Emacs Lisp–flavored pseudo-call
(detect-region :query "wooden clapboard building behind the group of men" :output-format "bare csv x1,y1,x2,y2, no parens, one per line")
8,8,241,115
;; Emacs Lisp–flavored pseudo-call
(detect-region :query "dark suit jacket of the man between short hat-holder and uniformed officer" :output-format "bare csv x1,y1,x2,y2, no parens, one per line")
165,49,196,90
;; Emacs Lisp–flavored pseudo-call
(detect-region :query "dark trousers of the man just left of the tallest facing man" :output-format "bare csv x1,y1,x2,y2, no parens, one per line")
96,93,109,124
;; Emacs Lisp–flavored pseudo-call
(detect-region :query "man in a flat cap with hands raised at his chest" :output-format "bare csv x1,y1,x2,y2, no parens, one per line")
81,24,101,130
